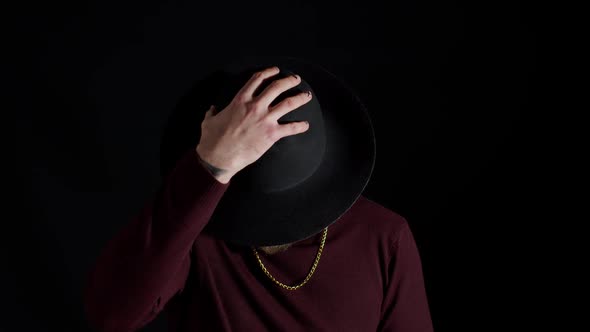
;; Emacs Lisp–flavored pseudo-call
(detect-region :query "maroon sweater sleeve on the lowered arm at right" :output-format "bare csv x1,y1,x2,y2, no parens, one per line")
378,220,433,332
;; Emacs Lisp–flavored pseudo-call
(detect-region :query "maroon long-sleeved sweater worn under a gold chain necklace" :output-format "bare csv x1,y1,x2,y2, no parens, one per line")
84,151,433,332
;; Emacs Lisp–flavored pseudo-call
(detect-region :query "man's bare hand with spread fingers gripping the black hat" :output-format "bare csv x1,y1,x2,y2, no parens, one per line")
196,67,312,183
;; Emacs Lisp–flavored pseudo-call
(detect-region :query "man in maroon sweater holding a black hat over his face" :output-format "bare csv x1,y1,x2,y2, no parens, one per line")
84,59,432,332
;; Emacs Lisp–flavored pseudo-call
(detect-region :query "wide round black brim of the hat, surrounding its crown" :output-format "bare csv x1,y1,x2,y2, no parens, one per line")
160,57,376,246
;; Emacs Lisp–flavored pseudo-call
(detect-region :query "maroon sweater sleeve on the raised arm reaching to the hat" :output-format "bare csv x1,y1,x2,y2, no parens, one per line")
84,149,231,332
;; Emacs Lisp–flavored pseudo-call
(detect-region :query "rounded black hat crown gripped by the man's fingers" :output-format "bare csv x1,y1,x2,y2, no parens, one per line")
216,67,326,193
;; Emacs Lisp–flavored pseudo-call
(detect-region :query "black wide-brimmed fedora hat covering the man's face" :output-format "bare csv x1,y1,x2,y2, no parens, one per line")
160,56,376,246
